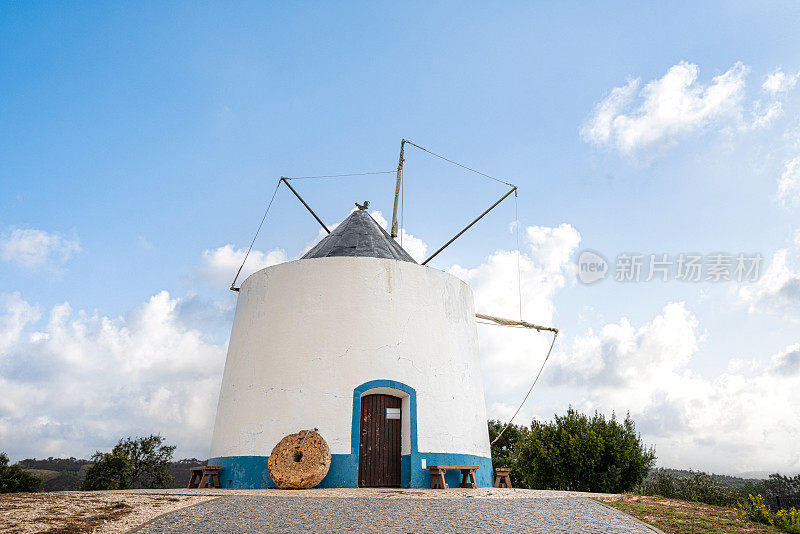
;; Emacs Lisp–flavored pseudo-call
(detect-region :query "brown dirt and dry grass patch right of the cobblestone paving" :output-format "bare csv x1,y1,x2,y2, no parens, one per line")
599,495,780,534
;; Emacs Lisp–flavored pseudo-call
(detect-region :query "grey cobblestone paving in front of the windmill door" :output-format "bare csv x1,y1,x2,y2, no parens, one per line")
135,495,657,534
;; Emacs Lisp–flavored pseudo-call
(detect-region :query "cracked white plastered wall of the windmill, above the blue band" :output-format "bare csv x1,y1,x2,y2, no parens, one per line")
211,257,490,457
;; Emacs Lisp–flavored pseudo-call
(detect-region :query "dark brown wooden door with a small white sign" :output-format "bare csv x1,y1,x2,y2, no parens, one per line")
358,395,401,487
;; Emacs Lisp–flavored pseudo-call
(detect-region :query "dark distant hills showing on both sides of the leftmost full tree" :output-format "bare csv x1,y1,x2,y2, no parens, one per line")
19,457,207,491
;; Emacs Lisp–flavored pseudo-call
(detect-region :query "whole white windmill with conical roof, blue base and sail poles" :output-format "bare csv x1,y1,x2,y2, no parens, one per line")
209,141,556,488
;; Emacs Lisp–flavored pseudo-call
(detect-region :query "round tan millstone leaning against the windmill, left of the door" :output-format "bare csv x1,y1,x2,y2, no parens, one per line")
267,430,331,489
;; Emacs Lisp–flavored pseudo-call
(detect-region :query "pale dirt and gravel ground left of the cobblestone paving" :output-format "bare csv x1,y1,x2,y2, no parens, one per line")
0,492,215,534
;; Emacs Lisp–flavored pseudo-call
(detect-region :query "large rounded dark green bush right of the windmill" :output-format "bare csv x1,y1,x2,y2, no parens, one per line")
516,407,656,493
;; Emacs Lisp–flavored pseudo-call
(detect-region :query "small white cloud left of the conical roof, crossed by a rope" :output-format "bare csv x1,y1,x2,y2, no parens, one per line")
199,244,287,287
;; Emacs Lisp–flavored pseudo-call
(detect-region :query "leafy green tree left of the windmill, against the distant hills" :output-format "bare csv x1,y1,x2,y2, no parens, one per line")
81,435,175,490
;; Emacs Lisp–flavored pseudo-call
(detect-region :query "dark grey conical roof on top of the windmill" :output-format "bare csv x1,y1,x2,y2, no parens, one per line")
300,210,416,263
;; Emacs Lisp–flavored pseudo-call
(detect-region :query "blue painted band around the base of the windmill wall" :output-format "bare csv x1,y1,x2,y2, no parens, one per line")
208,452,493,489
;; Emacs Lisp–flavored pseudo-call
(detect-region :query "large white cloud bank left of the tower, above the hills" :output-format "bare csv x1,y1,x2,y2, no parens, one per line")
0,291,228,458
